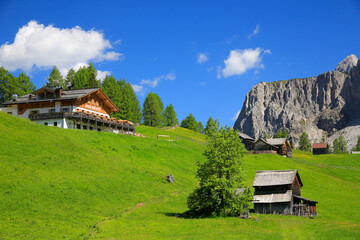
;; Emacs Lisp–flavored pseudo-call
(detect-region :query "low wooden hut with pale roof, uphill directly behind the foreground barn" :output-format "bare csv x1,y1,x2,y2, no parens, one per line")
253,138,292,158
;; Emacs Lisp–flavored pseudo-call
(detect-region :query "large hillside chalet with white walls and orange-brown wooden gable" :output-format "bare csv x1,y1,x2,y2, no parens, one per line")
0,87,135,133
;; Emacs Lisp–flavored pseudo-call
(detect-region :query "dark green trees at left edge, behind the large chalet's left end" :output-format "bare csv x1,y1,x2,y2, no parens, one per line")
0,67,36,103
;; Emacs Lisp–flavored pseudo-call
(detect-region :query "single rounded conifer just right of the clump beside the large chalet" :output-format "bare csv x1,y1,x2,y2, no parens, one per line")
143,92,164,127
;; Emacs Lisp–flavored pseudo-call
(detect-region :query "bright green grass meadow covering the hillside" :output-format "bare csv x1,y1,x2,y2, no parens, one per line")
0,112,360,239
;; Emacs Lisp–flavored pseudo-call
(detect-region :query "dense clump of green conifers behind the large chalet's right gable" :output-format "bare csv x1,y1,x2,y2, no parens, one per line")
101,76,142,123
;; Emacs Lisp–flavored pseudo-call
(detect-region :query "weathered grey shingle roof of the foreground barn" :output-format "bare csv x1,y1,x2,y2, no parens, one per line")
253,170,303,187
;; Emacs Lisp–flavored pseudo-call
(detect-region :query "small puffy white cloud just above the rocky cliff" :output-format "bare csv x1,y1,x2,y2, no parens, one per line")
218,48,270,78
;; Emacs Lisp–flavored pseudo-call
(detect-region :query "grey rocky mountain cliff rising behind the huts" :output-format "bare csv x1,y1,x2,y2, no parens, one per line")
234,55,360,149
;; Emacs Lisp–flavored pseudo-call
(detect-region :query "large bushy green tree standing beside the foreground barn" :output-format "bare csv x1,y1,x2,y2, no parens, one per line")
187,127,251,216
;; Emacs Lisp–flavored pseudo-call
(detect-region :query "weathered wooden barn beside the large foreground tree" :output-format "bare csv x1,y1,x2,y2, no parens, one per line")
252,170,318,216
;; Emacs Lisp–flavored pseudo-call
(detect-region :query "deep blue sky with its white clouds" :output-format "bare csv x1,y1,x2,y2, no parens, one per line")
0,0,360,126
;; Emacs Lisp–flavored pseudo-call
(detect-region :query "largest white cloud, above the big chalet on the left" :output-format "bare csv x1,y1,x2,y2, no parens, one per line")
0,21,123,71
